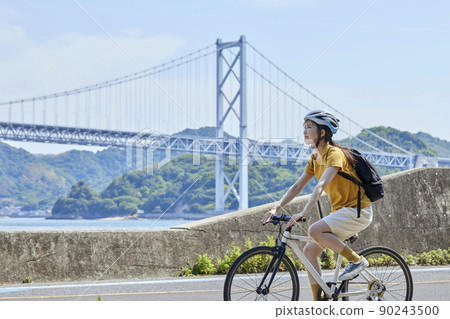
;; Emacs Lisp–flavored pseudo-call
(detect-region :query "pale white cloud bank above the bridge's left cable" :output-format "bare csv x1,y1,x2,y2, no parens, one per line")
0,20,185,102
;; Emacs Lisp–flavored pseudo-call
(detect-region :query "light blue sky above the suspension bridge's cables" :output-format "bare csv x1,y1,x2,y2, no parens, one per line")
0,0,450,153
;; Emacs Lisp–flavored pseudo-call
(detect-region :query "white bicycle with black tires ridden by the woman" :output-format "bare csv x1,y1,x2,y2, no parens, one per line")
223,215,413,301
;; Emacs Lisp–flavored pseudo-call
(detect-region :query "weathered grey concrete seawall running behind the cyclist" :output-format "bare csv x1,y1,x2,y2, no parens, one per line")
0,168,450,284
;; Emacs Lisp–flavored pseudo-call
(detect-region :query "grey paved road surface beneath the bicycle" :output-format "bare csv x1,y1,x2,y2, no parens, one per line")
0,266,450,301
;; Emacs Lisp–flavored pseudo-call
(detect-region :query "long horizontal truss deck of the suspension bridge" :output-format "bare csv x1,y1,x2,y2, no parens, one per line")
0,122,420,169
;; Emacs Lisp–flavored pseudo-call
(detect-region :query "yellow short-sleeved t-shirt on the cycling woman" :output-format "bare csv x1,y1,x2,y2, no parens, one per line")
305,145,370,212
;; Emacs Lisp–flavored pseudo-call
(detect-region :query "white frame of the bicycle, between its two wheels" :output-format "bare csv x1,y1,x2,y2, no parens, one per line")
281,231,378,298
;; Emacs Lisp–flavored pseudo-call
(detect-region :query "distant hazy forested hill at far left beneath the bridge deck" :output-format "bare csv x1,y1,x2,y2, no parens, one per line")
0,142,126,210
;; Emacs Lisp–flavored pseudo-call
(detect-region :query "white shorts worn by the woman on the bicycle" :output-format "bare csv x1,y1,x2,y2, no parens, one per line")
322,206,373,240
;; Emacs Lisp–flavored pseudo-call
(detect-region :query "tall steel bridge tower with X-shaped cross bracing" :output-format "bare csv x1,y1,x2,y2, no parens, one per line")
216,36,249,212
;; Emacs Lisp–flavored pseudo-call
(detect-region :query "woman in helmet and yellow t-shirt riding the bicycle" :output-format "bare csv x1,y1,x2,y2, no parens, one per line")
262,110,372,300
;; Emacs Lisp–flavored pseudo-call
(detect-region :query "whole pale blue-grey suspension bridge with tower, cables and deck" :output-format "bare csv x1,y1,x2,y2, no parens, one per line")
0,36,450,211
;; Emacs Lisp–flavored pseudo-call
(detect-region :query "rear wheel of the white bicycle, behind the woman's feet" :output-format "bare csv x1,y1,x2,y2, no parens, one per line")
343,246,413,301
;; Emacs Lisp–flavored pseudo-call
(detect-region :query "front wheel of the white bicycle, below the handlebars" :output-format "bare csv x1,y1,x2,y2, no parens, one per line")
223,246,299,301
